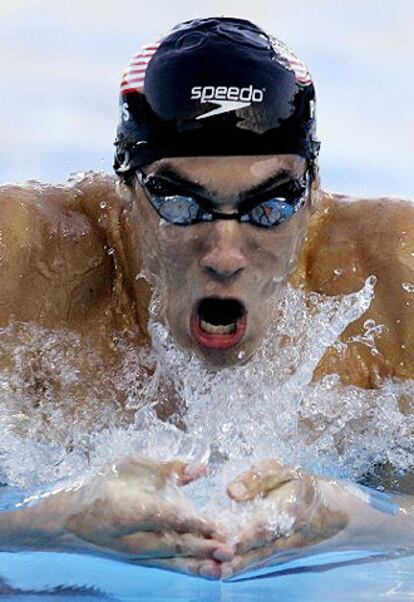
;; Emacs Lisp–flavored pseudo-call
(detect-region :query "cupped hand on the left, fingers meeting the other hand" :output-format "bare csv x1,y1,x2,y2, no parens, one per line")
65,456,234,578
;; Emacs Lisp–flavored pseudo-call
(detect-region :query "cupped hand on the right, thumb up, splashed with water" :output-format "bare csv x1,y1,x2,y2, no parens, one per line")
224,460,348,573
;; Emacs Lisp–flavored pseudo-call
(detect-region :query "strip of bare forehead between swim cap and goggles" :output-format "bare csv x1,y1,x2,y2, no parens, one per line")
145,155,305,195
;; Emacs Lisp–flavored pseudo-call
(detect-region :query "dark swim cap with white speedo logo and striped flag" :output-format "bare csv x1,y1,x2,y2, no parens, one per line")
114,17,319,181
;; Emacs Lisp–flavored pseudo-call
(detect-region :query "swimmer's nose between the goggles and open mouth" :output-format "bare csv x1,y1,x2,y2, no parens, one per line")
199,220,247,282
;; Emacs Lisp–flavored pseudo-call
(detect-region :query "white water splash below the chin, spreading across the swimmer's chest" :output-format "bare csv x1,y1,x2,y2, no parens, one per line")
0,278,414,512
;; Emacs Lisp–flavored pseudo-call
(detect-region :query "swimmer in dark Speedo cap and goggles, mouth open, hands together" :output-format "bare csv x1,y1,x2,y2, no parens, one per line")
0,17,414,578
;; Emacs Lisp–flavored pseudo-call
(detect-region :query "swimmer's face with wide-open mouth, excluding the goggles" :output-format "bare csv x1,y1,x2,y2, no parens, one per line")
131,155,316,367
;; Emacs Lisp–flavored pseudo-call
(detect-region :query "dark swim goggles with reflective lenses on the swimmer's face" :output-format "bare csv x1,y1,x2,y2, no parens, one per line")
136,170,310,228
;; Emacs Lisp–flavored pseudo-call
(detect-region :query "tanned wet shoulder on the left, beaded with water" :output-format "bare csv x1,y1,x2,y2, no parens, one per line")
0,171,116,322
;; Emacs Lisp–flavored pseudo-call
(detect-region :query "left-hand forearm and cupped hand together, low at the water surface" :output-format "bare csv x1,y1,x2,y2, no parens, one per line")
0,455,223,576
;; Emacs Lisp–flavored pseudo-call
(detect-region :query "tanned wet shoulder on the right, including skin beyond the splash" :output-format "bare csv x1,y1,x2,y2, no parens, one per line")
306,195,414,387
